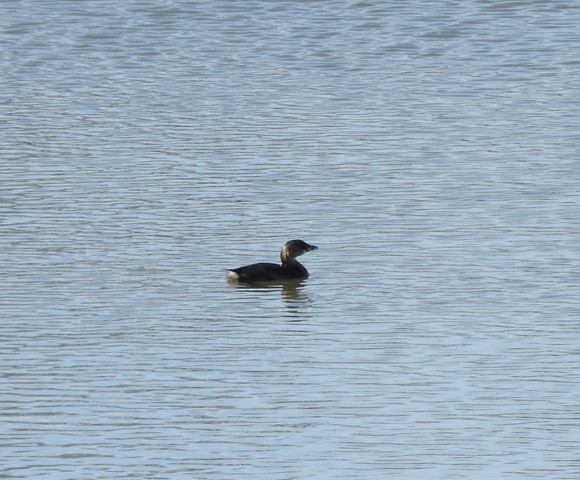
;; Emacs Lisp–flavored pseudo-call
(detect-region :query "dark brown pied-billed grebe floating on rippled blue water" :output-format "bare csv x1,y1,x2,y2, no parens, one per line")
227,240,318,283
